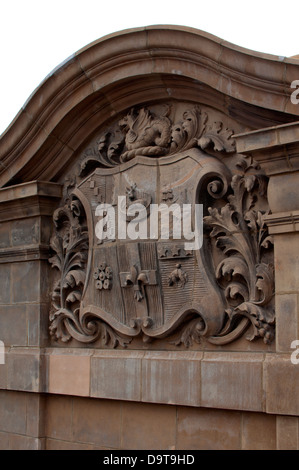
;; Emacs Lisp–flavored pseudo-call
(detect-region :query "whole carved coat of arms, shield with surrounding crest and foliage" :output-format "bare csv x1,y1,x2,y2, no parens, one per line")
49,101,275,347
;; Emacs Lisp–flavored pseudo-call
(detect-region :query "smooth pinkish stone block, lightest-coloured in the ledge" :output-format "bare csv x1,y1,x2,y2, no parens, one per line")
48,351,90,396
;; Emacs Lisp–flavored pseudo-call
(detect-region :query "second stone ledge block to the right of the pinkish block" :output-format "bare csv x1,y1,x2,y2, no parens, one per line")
142,351,203,406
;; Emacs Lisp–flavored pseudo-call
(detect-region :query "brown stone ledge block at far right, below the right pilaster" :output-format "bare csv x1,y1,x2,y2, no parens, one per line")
264,350,299,416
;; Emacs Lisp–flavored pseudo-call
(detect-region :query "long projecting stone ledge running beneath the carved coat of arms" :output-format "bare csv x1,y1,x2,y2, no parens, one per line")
0,348,299,416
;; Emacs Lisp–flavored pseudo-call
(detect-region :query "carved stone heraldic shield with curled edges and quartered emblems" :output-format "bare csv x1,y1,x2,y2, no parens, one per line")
74,149,229,346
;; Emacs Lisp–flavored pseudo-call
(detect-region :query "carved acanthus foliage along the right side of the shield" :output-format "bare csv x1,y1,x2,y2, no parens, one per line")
204,158,275,344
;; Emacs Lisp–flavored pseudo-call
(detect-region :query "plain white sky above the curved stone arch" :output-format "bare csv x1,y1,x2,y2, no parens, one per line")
0,0,299,134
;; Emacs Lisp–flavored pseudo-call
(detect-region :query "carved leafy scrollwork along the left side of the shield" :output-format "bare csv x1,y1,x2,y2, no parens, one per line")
49,199,130,347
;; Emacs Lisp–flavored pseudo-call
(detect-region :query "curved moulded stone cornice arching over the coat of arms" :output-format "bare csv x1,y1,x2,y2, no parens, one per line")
0,26,299,186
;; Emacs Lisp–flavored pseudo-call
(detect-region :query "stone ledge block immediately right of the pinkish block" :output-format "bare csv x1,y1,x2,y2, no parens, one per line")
91,351,144,401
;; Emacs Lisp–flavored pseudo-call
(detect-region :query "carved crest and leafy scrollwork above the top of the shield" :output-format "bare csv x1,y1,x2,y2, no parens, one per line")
79,105,235,176
